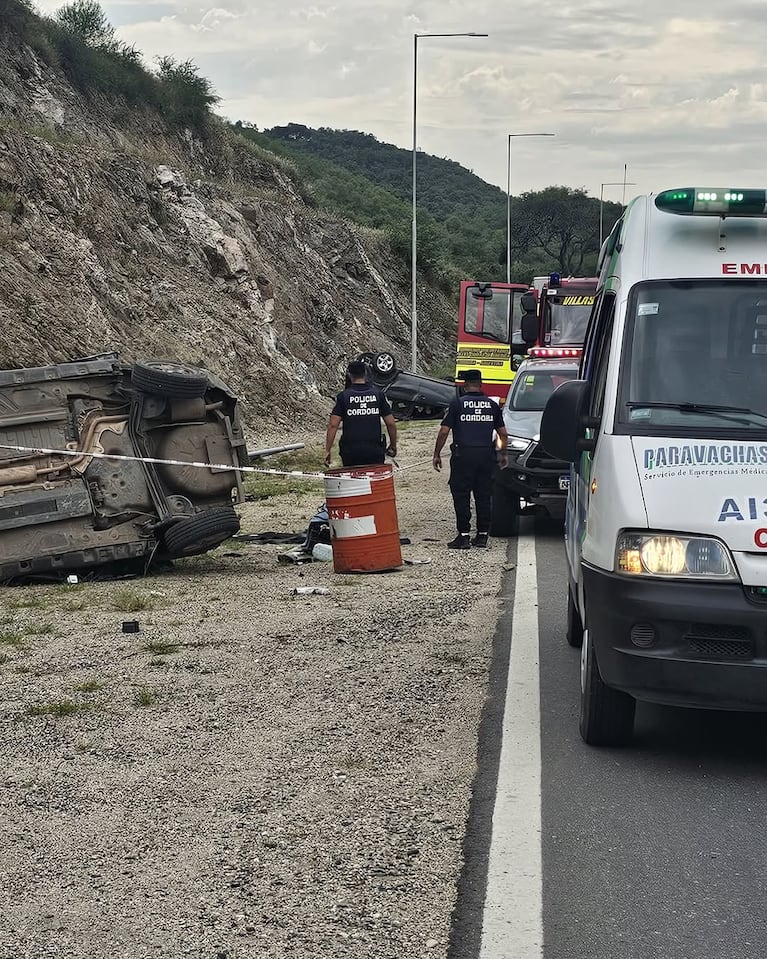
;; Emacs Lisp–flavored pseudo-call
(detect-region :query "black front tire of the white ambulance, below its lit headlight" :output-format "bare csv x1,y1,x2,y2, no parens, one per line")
580,631,636,746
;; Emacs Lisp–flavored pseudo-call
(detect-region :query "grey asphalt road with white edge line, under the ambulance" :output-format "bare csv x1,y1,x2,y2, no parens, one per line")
449,520,767,959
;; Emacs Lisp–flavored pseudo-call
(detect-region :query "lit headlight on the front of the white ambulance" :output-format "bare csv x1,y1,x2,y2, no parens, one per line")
615,532,737,581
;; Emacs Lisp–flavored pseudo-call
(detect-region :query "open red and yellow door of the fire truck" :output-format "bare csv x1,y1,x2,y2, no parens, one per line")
455,280,536,404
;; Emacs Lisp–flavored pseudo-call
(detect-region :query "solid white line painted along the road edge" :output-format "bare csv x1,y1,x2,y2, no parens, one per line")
480,536,543,959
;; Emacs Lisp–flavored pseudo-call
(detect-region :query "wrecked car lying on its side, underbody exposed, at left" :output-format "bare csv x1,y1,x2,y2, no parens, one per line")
0,353,248,582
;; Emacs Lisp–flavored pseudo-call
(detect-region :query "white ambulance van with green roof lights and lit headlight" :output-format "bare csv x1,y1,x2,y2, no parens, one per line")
541,188,767,745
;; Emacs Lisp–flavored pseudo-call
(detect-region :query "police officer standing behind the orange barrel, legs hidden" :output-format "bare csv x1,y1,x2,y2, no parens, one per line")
325,362,397,466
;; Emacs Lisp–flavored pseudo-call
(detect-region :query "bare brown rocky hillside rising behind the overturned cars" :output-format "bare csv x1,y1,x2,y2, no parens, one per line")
0,30,454,442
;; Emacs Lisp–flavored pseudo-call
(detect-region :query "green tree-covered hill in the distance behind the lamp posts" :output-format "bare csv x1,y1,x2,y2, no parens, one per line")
234,123,621,290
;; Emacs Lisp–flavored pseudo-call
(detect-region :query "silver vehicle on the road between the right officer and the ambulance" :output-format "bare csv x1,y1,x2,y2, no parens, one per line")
490,359,578,536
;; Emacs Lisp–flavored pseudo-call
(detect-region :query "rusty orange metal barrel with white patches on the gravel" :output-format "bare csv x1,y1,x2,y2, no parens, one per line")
325,464,402,573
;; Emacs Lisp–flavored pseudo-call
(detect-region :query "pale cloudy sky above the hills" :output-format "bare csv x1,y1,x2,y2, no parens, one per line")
33,0,767,201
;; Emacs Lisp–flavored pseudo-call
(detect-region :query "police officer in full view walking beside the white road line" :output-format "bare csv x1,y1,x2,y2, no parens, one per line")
432,370,508,549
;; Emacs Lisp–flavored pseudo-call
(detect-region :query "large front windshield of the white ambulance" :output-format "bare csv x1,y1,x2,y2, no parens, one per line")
619,280,767,432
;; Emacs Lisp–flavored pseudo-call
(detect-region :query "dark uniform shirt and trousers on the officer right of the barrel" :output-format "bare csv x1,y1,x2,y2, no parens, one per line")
442,393,504,533
